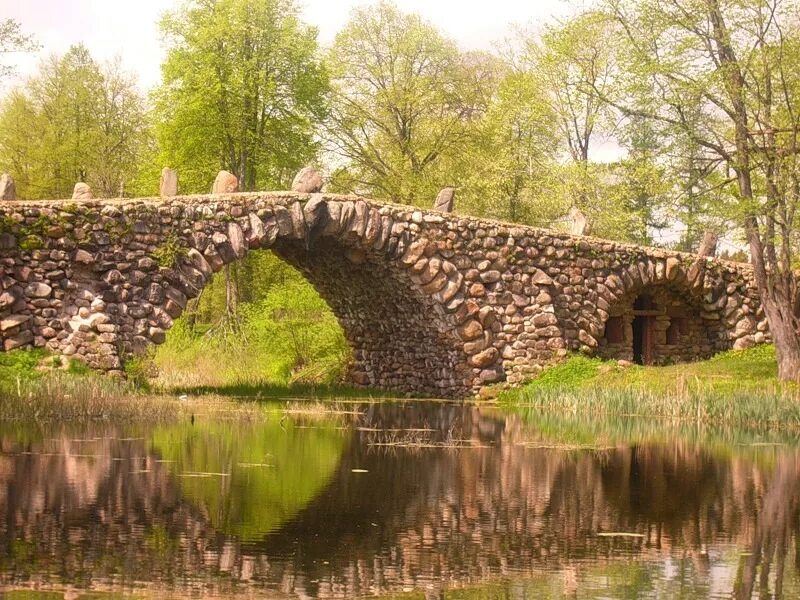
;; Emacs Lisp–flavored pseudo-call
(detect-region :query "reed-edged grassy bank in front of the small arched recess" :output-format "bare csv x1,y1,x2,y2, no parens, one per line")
500,345,800,429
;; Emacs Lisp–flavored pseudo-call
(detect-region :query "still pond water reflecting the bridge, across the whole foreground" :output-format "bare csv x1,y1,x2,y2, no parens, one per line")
0,402,800,599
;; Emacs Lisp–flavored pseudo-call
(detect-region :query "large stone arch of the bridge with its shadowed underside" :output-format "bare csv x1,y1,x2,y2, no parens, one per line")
122,195,482,396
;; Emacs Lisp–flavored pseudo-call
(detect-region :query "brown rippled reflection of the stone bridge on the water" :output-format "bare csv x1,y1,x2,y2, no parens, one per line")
0,404,800,598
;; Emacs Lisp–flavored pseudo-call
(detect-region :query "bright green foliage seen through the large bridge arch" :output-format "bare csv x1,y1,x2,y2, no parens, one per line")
154,252,350,388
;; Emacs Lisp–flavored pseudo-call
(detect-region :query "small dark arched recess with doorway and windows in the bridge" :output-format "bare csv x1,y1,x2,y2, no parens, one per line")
598,283,727,365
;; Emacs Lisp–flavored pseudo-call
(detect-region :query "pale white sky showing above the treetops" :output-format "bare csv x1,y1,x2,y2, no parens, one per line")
0,0,570,90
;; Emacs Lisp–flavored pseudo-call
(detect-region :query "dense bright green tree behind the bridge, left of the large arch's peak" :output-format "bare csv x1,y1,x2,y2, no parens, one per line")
154,0,327,192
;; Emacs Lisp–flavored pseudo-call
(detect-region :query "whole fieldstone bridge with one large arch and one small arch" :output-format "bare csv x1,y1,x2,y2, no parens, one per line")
0,192,769,397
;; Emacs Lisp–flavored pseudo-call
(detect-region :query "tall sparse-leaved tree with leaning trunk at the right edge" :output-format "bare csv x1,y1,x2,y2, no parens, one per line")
594,0,800,380
